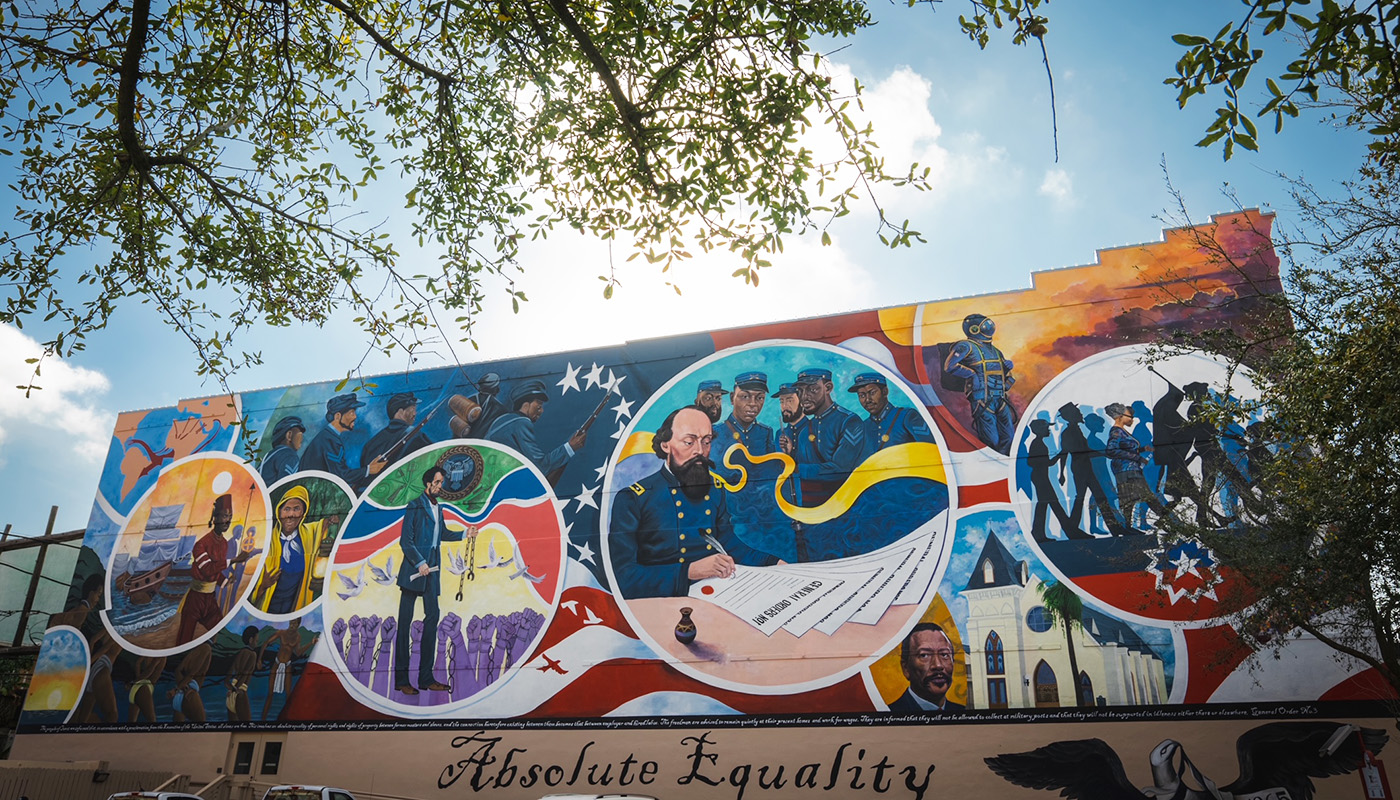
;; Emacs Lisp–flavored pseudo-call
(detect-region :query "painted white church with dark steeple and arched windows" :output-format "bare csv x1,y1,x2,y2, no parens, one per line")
962,532,1168,709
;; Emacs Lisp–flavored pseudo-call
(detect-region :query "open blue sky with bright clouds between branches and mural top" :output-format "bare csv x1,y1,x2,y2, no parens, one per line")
0,0,1365,534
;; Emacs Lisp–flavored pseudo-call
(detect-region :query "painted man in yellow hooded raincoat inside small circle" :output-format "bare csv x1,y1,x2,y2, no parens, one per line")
253,486,339,614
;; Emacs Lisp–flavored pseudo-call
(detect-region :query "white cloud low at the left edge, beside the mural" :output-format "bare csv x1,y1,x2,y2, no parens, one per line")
0,325,116,464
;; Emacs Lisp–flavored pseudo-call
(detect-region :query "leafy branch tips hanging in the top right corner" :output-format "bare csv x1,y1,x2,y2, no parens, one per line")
1166,0,1400,158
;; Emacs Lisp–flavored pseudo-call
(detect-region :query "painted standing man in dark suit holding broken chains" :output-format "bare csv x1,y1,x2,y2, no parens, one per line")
393,467,476,695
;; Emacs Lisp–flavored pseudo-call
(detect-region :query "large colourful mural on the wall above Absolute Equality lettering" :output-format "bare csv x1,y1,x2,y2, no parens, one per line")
16,214,1394,734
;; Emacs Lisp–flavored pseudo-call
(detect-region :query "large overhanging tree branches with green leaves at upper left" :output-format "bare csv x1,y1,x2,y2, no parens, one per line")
0,0,952,386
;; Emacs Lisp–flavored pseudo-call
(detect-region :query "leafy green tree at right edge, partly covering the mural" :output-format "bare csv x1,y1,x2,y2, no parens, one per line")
1168,167,1400,694
